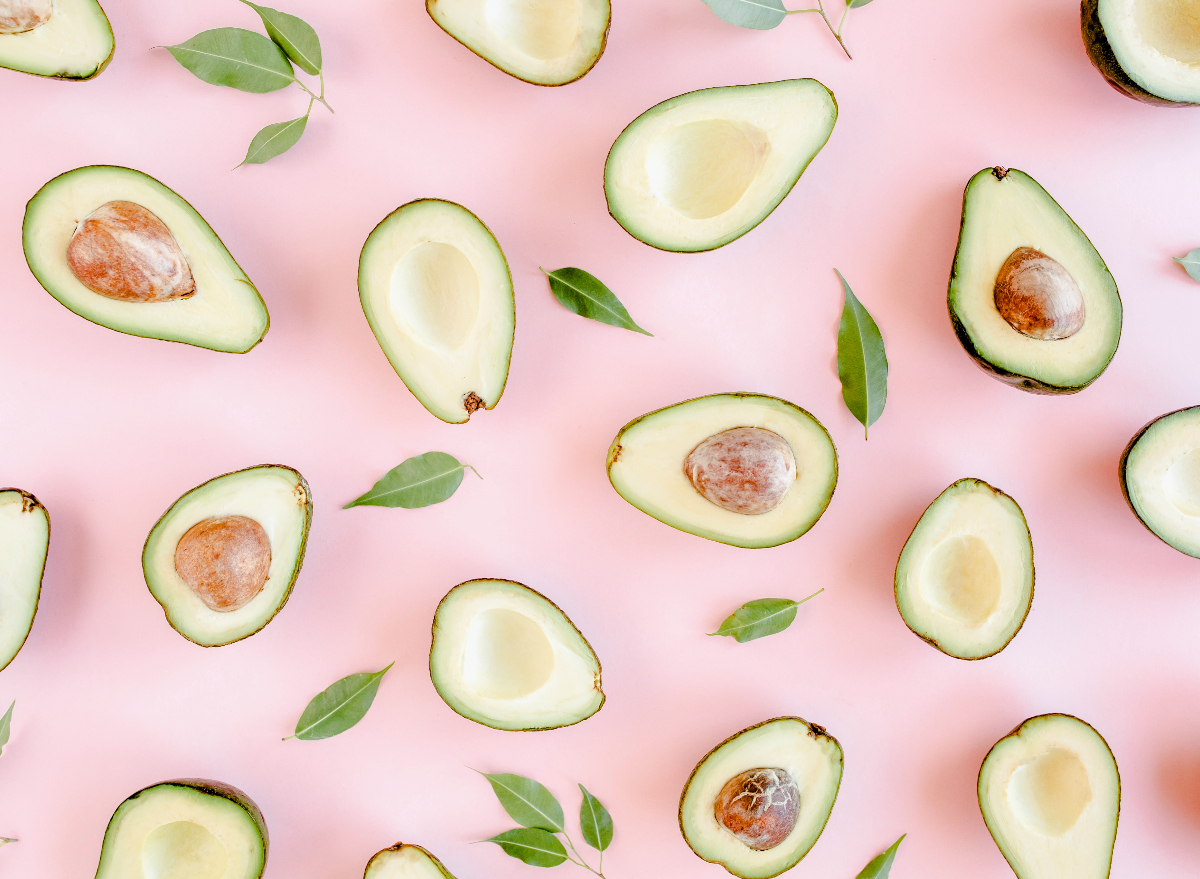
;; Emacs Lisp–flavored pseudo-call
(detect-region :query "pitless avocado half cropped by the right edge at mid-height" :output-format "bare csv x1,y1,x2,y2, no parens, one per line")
1117,406,1200,558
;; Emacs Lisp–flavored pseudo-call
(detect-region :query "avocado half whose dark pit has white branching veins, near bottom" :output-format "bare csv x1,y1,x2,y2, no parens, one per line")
679,717,842,879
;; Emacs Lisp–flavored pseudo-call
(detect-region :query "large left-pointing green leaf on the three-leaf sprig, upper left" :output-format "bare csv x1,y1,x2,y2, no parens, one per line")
163,28,296,95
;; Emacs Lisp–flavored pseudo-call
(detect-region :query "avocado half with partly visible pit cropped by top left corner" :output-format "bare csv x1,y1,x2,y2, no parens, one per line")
0,0,115,79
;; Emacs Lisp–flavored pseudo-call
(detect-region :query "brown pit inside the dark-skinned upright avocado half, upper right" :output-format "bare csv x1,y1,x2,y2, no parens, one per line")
992,247,1087,341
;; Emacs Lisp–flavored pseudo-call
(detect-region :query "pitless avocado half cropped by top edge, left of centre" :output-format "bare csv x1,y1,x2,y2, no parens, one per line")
425,0,611,85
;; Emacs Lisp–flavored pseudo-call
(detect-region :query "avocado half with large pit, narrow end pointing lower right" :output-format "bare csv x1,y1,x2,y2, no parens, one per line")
23,165,270,353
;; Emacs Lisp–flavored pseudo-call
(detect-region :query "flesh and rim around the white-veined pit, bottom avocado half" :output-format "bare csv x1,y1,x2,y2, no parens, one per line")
679,717,842,879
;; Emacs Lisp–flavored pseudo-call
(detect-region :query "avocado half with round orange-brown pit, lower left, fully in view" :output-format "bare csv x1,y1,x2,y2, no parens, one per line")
142,465,312,647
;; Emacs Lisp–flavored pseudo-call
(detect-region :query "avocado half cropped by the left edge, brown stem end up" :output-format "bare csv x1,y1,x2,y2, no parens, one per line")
0,489,50,671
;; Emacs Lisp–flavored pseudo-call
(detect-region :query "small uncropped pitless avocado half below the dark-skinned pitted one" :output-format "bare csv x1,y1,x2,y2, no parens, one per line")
895,479,1033,659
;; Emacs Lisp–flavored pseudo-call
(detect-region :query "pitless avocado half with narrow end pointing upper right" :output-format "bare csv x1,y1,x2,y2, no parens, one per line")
604,79,838,252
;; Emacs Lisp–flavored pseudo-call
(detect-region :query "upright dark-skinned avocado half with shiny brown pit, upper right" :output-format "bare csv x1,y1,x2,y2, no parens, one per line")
947,168,1121,394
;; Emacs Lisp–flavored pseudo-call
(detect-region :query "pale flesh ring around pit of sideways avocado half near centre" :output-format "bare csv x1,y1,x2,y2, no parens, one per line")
608,394,838,548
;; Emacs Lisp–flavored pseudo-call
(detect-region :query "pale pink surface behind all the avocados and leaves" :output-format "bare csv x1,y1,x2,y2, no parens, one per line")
0,0,1200,879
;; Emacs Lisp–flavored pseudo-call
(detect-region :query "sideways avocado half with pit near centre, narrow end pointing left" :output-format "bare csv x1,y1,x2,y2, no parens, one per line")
608,394,838,548
